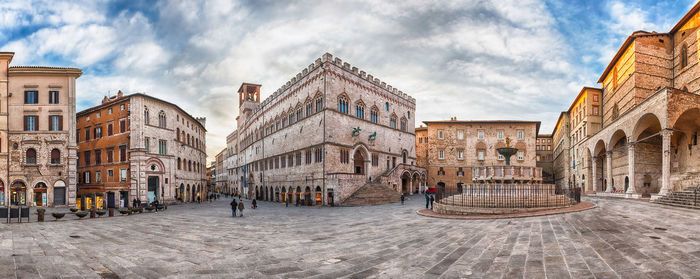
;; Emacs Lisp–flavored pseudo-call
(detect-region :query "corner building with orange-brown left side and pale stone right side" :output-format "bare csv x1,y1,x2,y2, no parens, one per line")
76,91,206,209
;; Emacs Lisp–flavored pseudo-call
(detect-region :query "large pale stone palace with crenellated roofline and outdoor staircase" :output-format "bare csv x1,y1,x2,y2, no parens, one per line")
227,54,424,205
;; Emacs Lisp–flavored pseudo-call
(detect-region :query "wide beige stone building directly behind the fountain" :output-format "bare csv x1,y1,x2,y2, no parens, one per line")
417,118,542,190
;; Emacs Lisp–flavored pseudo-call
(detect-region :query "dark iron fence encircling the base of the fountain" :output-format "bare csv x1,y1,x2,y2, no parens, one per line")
435,184,581,208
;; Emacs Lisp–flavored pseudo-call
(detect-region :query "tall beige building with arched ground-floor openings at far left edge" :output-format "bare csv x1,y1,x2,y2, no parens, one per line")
0,52,82,206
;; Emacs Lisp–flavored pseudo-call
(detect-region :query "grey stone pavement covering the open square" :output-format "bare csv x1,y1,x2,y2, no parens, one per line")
0,196,700,279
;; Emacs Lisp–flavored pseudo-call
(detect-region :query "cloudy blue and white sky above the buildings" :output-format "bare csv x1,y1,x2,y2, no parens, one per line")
0,0,695,161
